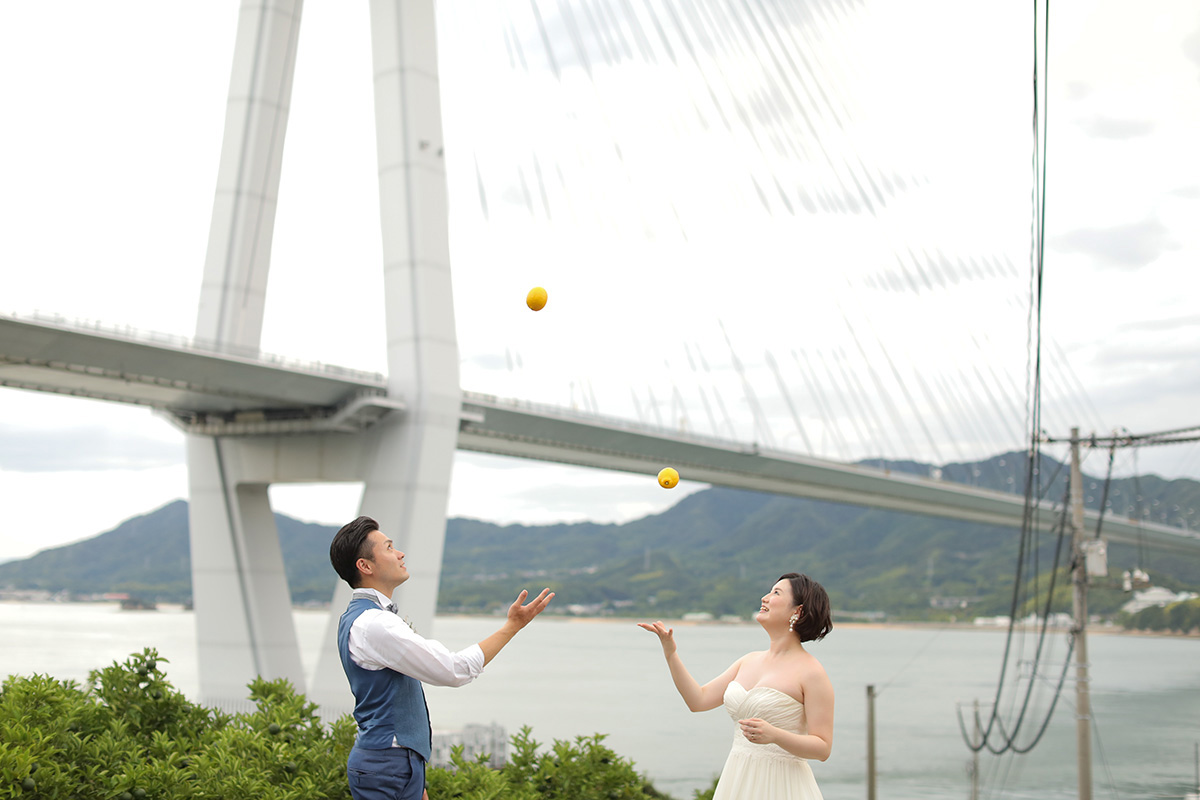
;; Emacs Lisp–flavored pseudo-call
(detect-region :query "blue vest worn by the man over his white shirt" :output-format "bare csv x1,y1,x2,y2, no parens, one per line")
337,597,433,762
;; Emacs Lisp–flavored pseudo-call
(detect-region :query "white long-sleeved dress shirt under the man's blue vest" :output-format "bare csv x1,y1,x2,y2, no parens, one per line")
349,588,484,686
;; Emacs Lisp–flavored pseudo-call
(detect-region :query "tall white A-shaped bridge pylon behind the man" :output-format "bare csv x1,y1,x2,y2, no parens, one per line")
187,0,461,702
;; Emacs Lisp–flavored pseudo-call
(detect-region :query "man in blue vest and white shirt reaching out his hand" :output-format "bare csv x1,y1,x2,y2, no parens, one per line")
329,517,554,800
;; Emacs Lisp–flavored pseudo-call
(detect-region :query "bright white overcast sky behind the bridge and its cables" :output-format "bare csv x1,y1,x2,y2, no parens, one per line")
0,0,1200,559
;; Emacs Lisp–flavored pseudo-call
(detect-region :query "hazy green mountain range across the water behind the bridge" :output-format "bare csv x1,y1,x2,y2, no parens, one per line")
0,453,1200,619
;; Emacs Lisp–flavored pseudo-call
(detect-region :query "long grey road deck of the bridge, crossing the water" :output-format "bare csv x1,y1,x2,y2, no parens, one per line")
0,309,1200,554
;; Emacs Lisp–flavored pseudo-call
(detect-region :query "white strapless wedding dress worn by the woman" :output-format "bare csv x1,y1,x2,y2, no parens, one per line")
713,680,822,800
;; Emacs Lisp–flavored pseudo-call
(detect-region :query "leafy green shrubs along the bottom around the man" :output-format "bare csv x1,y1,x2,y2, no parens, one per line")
0,649,676,800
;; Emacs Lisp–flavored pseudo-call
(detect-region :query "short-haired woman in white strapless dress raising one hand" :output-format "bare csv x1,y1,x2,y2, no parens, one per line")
637,572,833,800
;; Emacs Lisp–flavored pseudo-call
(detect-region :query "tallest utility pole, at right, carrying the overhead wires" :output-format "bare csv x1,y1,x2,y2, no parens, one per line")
1070,428,1092,800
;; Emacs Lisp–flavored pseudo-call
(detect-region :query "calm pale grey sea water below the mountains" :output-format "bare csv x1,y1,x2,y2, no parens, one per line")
0,602,1200,800
